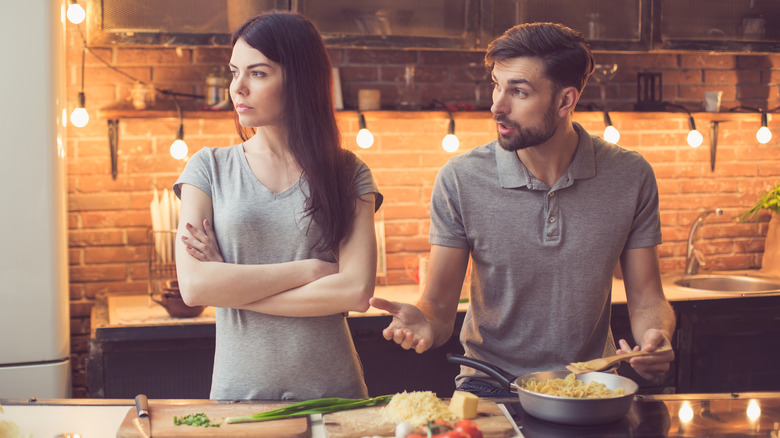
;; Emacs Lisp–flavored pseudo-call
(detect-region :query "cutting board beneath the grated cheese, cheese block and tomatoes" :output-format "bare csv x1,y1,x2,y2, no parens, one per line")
322,399,515,438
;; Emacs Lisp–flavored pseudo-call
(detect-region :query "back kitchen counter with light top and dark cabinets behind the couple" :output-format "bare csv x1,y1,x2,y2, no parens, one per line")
87,279,780,399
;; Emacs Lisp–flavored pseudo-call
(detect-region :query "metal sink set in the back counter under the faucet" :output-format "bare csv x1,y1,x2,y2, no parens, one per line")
664,272,780,295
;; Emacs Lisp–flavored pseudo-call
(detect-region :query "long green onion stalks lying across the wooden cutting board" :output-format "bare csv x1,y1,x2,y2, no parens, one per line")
225,395,393,424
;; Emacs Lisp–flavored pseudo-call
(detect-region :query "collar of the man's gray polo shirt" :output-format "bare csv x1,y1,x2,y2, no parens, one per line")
495,122,596,189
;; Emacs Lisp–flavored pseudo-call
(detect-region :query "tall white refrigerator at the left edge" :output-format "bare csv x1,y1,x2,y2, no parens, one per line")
0,0,71,399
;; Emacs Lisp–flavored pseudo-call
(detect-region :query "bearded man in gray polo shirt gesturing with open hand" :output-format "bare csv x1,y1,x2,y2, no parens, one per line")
371,23,675,396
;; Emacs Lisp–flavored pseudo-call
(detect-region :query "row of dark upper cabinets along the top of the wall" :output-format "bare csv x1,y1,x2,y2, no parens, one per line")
87,0,780,52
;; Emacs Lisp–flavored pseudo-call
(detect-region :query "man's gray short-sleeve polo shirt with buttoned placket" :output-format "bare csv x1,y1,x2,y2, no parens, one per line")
429,123,661,383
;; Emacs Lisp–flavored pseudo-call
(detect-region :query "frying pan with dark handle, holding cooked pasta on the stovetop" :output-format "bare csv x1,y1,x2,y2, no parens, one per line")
447,353,639,425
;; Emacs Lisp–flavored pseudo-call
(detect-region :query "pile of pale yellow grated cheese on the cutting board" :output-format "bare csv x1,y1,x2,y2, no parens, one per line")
382,391,458,427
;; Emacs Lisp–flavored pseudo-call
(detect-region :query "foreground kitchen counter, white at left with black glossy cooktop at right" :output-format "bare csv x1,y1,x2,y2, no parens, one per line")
0,392,780,438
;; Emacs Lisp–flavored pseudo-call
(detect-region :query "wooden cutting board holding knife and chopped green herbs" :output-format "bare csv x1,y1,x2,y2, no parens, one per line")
116,400,311,438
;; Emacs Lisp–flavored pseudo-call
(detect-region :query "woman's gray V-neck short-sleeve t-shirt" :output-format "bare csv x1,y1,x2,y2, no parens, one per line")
173,144,381,400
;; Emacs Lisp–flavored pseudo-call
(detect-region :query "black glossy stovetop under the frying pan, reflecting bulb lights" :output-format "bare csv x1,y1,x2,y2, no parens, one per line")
504,393,780,438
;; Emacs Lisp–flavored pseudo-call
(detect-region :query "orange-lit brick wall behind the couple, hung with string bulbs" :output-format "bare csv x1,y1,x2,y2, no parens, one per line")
65,21,780,397
